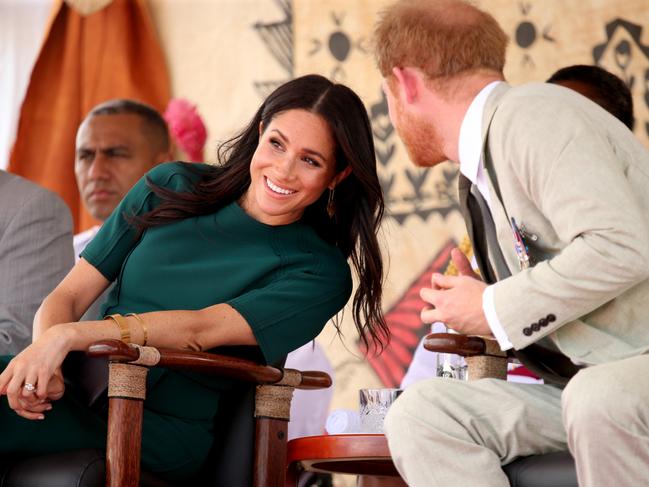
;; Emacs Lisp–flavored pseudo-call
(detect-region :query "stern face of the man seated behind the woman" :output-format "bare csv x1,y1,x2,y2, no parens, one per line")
74,113,164,221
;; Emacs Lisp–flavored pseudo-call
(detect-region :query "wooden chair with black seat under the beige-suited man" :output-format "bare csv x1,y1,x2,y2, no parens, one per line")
424,333,577,487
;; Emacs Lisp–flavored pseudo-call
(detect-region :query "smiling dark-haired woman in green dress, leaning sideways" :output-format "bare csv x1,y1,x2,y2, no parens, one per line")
0,75,387,478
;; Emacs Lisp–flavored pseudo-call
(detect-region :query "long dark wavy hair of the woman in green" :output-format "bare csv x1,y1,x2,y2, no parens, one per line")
130,75,389,350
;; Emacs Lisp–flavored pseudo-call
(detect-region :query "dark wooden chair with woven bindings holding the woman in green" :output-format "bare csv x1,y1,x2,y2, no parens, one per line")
0,340,331,487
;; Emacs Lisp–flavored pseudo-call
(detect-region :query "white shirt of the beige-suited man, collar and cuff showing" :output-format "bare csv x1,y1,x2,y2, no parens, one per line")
459,81,513,350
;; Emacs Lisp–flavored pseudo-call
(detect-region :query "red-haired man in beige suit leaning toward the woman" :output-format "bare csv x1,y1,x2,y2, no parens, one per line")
375,0,649,487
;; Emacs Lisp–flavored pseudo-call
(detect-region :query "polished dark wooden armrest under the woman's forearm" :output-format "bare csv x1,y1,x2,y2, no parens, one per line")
87,340,331,389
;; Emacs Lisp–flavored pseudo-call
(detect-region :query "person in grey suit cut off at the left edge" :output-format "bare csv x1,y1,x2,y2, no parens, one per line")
0,170,74,355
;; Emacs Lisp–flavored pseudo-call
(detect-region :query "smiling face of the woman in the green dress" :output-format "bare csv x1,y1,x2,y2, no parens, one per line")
242,109,347,225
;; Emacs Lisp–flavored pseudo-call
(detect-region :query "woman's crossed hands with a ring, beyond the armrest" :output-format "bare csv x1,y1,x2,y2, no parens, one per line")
0,326,71,419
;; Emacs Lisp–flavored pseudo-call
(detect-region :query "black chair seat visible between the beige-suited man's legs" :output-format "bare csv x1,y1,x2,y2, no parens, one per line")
503,452,577,487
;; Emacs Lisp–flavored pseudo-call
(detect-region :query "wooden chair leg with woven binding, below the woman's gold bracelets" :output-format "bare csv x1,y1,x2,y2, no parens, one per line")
106,363,148,487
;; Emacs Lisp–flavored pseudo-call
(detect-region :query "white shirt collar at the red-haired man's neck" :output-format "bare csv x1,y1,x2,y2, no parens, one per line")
459,81,502,184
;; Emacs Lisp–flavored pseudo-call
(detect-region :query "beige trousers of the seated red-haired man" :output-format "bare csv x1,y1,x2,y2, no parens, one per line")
385,355,649,487
